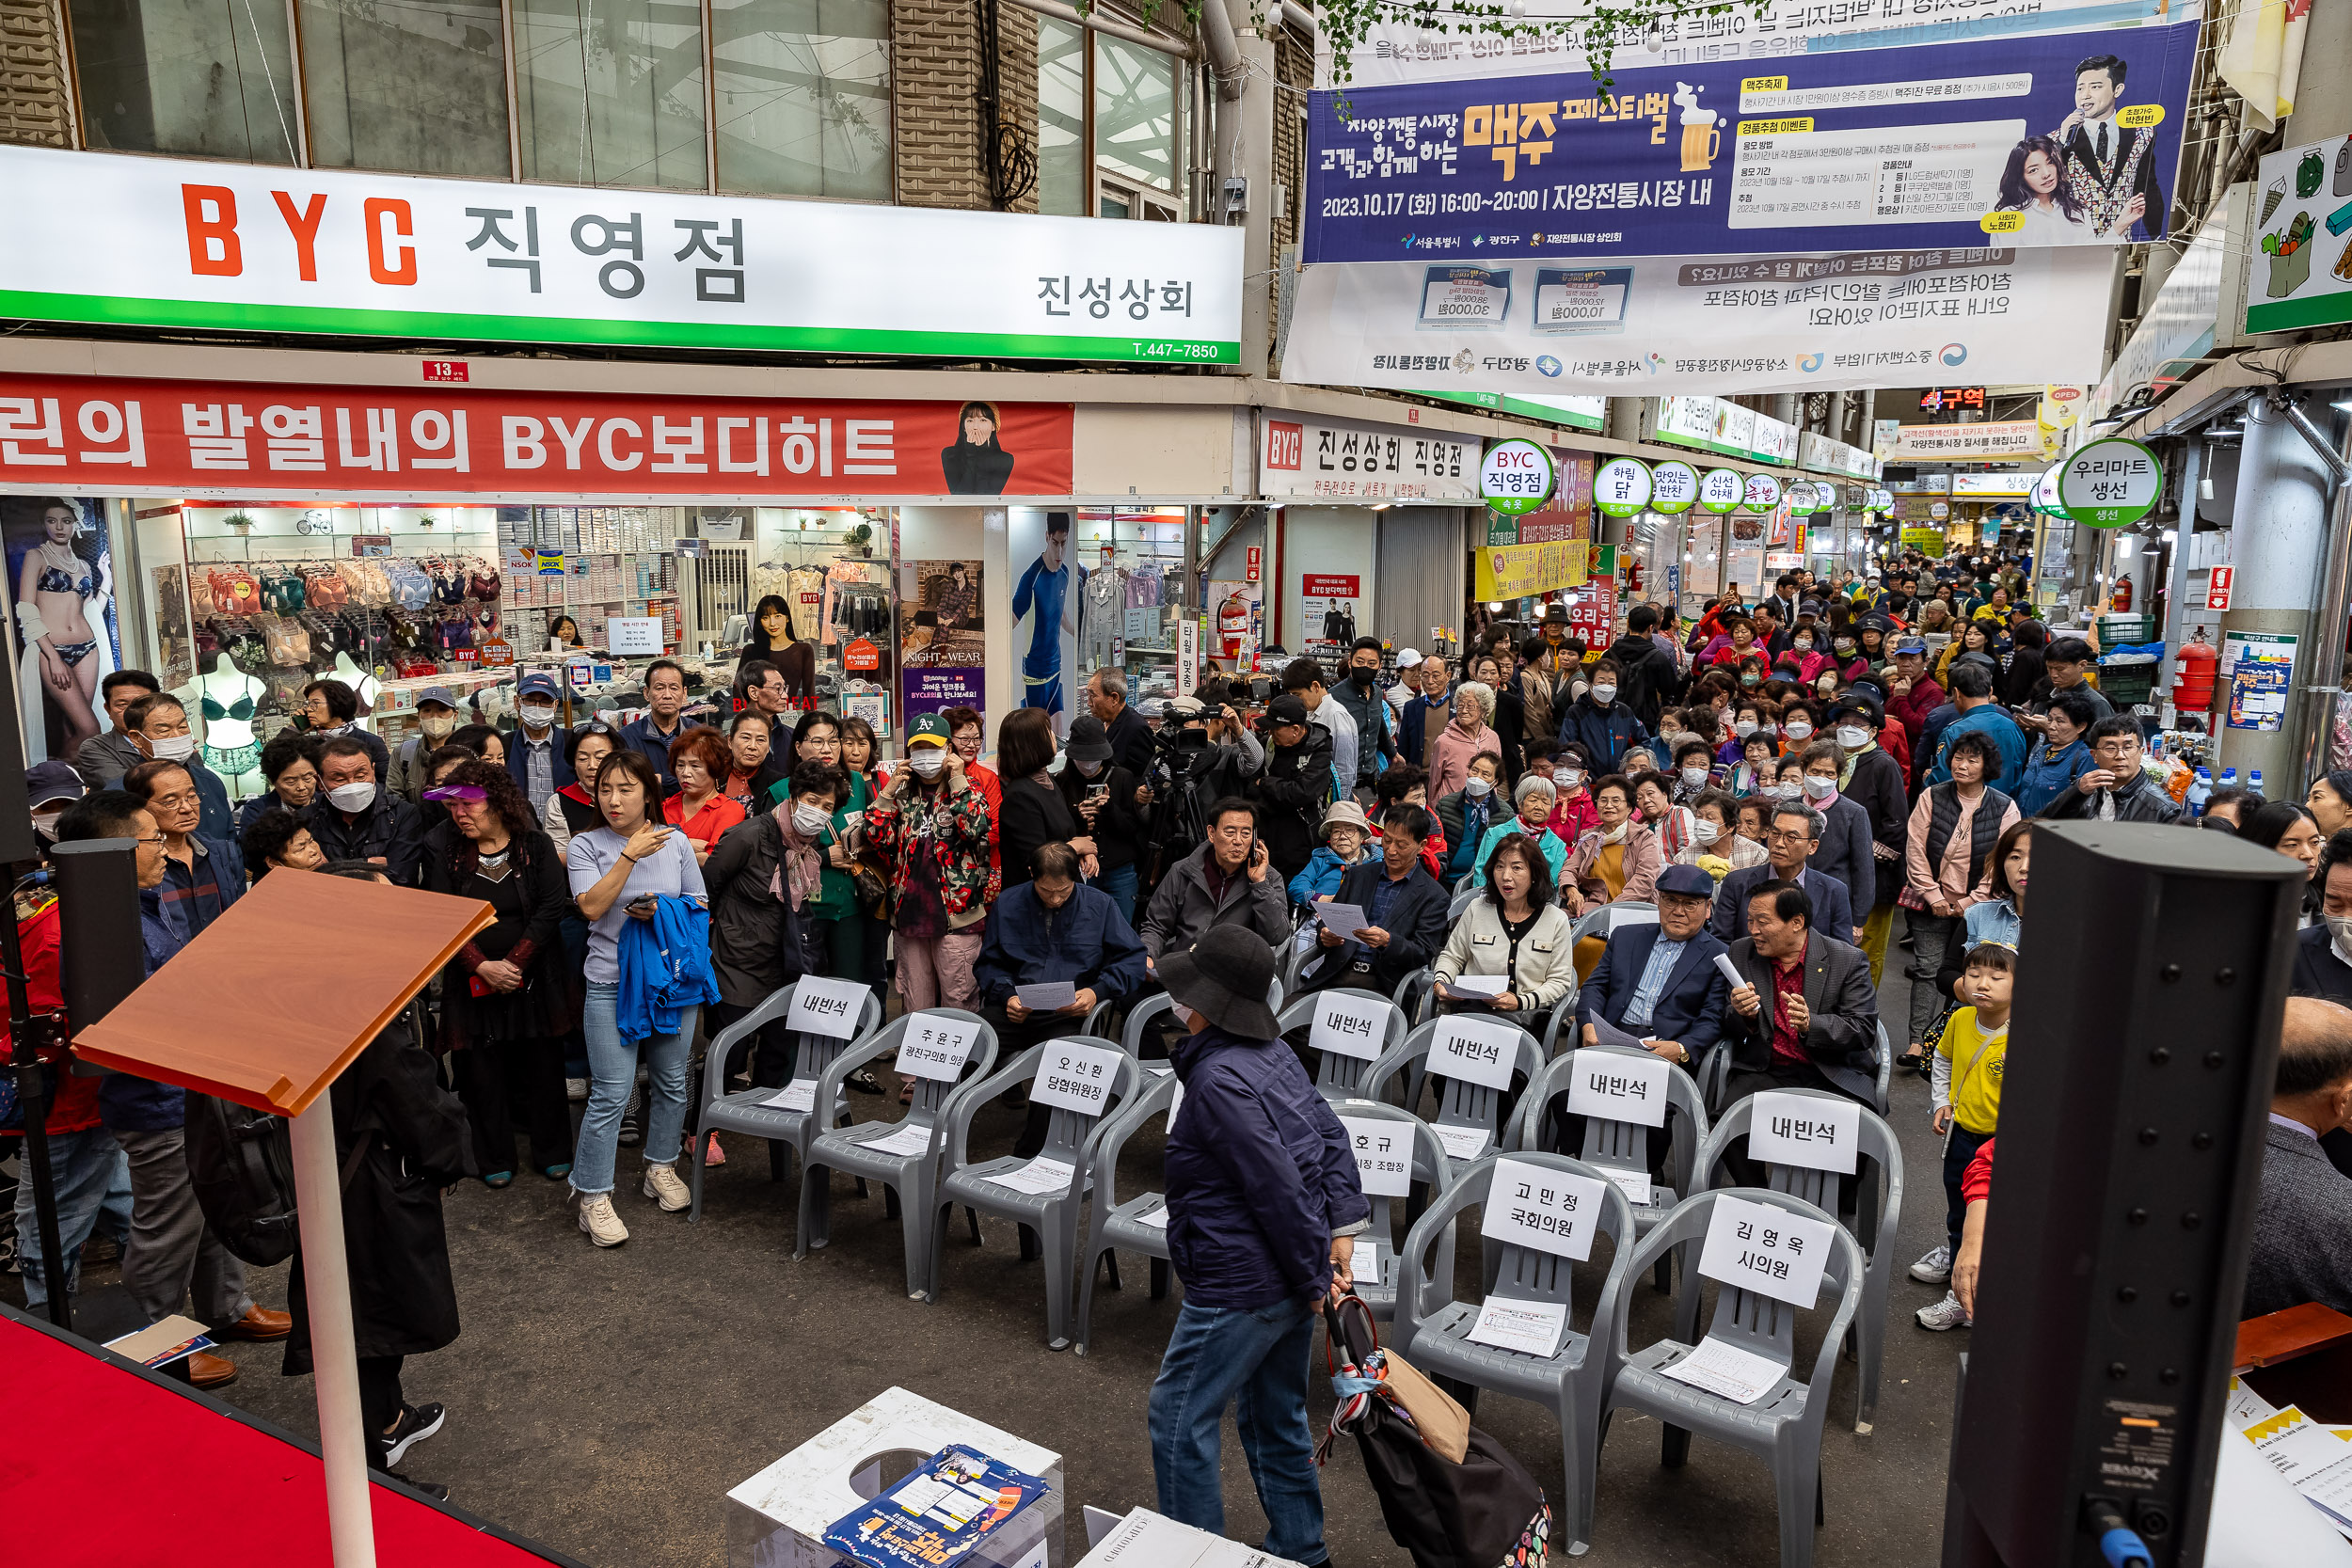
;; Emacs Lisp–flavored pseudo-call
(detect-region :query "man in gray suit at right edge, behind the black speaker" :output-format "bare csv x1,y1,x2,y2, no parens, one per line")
2239,997,2352,1317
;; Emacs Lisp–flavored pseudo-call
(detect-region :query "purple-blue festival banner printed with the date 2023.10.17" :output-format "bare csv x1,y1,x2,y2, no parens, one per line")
1306,21,2197,265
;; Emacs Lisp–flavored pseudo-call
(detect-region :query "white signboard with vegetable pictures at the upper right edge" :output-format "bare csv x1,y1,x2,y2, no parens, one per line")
2242,136,2352,331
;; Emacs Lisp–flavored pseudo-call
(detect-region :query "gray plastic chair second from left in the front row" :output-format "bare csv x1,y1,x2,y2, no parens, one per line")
793,1006,997,1300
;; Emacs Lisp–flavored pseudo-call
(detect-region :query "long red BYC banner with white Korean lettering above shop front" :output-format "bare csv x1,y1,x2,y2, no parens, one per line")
0,376,1073,500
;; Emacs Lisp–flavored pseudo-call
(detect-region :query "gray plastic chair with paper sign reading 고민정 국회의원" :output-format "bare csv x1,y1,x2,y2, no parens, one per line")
1392,1154,1632,1557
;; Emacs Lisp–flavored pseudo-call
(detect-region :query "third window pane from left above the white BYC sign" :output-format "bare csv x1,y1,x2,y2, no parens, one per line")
516,0,708,190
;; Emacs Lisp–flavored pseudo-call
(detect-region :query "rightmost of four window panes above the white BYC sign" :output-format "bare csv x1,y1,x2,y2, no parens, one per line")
710,0,892,202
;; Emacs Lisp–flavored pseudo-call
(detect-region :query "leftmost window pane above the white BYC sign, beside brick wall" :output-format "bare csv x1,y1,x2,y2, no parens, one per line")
71,0,301,165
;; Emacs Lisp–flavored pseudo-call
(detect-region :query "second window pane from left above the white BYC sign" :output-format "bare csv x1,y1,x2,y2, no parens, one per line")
301,0,508,179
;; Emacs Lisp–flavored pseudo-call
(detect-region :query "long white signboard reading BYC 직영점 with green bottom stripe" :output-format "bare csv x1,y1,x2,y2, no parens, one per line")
0,146,1245,364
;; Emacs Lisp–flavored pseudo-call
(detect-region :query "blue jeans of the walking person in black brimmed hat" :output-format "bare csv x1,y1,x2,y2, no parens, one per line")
1151,1295,1329,1566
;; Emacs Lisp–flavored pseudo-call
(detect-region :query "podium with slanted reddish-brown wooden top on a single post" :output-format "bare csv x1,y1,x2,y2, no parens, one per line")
73,870,492,1568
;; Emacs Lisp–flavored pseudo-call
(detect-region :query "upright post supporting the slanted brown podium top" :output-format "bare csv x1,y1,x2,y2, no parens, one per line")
292,1093,376,1568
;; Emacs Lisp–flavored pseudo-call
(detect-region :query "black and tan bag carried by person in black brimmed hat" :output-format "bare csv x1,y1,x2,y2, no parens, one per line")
1315,1293,1552,1568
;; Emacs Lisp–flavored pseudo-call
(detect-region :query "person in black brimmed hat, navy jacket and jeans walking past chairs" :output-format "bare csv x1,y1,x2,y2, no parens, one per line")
1151,927,1372,1568
